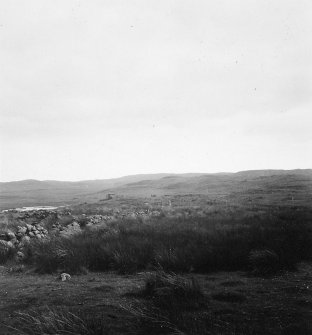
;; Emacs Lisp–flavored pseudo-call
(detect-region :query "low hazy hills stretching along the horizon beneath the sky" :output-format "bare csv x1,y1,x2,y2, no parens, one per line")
0,169,312,209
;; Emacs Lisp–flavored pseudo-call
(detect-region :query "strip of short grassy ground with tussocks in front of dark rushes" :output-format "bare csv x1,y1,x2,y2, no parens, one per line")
0,264,312,335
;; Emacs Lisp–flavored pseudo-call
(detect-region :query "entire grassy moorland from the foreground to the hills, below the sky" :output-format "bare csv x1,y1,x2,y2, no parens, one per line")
0,170,312,335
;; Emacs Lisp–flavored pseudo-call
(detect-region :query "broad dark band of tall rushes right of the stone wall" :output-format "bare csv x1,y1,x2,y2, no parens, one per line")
18,208,312,275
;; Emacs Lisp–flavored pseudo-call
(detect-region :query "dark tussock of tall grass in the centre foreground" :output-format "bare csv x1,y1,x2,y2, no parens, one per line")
135,269,207,334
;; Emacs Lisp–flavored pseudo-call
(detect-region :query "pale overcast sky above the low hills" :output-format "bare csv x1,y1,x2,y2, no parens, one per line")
0,0,312,181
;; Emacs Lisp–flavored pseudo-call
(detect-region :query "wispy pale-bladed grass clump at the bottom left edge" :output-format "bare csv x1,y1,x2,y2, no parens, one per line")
9,307,109,335
